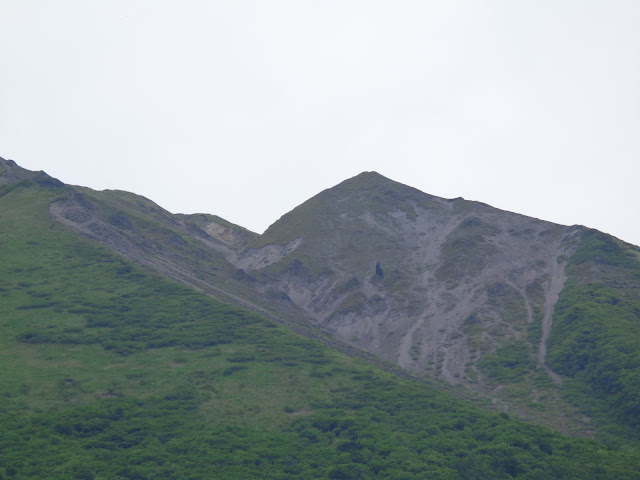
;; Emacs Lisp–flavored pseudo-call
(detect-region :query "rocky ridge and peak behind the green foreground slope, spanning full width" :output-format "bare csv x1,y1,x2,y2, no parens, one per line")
0,155,640,450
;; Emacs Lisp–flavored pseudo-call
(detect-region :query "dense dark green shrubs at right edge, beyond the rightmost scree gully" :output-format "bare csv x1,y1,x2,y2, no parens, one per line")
548,230,640,435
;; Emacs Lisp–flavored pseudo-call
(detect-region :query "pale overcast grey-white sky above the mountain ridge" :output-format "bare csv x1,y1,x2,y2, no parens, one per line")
0,0,640,245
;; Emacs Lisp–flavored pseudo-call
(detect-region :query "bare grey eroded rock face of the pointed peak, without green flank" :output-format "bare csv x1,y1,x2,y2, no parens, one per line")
232,173,581,383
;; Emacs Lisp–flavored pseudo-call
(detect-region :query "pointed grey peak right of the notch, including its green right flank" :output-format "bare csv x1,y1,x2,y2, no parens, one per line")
231,172,640,434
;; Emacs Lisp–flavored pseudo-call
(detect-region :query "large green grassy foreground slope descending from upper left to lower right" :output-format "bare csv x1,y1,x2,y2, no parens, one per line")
0,182,640,479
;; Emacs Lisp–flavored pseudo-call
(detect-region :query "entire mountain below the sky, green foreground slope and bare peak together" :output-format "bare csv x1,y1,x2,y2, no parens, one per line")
0,159,640,479
